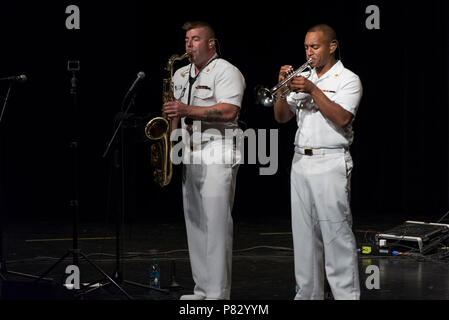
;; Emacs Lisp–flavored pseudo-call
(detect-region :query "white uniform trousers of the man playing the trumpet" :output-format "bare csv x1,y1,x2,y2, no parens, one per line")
291,152,360,300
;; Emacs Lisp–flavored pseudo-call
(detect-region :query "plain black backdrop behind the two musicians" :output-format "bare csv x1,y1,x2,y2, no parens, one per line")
0,1,449,222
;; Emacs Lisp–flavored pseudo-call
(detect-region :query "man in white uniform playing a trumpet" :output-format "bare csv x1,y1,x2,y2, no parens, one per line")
274,25,362,300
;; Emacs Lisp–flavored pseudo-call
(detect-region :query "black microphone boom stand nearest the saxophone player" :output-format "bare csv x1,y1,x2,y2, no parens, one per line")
103,79,169,294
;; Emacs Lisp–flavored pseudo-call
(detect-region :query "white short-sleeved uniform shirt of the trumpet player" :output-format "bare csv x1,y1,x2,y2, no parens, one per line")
287,61,362,149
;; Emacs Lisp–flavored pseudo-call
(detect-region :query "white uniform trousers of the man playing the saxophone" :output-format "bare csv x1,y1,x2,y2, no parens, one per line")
182,144,238,300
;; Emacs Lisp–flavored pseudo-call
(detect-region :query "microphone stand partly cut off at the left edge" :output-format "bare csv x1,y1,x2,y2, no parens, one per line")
0,77,48,281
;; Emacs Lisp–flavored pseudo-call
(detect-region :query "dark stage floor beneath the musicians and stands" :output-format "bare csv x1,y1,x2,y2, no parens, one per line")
2,212,449,300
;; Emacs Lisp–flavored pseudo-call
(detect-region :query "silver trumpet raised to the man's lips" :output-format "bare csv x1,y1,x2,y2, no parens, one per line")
256,58,312,107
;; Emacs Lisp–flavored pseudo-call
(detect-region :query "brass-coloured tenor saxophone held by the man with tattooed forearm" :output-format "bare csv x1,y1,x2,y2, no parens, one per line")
145,52,191,187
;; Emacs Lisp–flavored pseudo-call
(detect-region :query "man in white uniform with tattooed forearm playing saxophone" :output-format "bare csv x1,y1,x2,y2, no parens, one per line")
164,21,245,300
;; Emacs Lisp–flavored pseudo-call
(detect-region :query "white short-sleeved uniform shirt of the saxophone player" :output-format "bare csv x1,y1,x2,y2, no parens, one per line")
173,56,245,138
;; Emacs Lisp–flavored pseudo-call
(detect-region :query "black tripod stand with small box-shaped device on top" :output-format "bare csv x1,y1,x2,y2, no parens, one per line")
36,61,132,299
